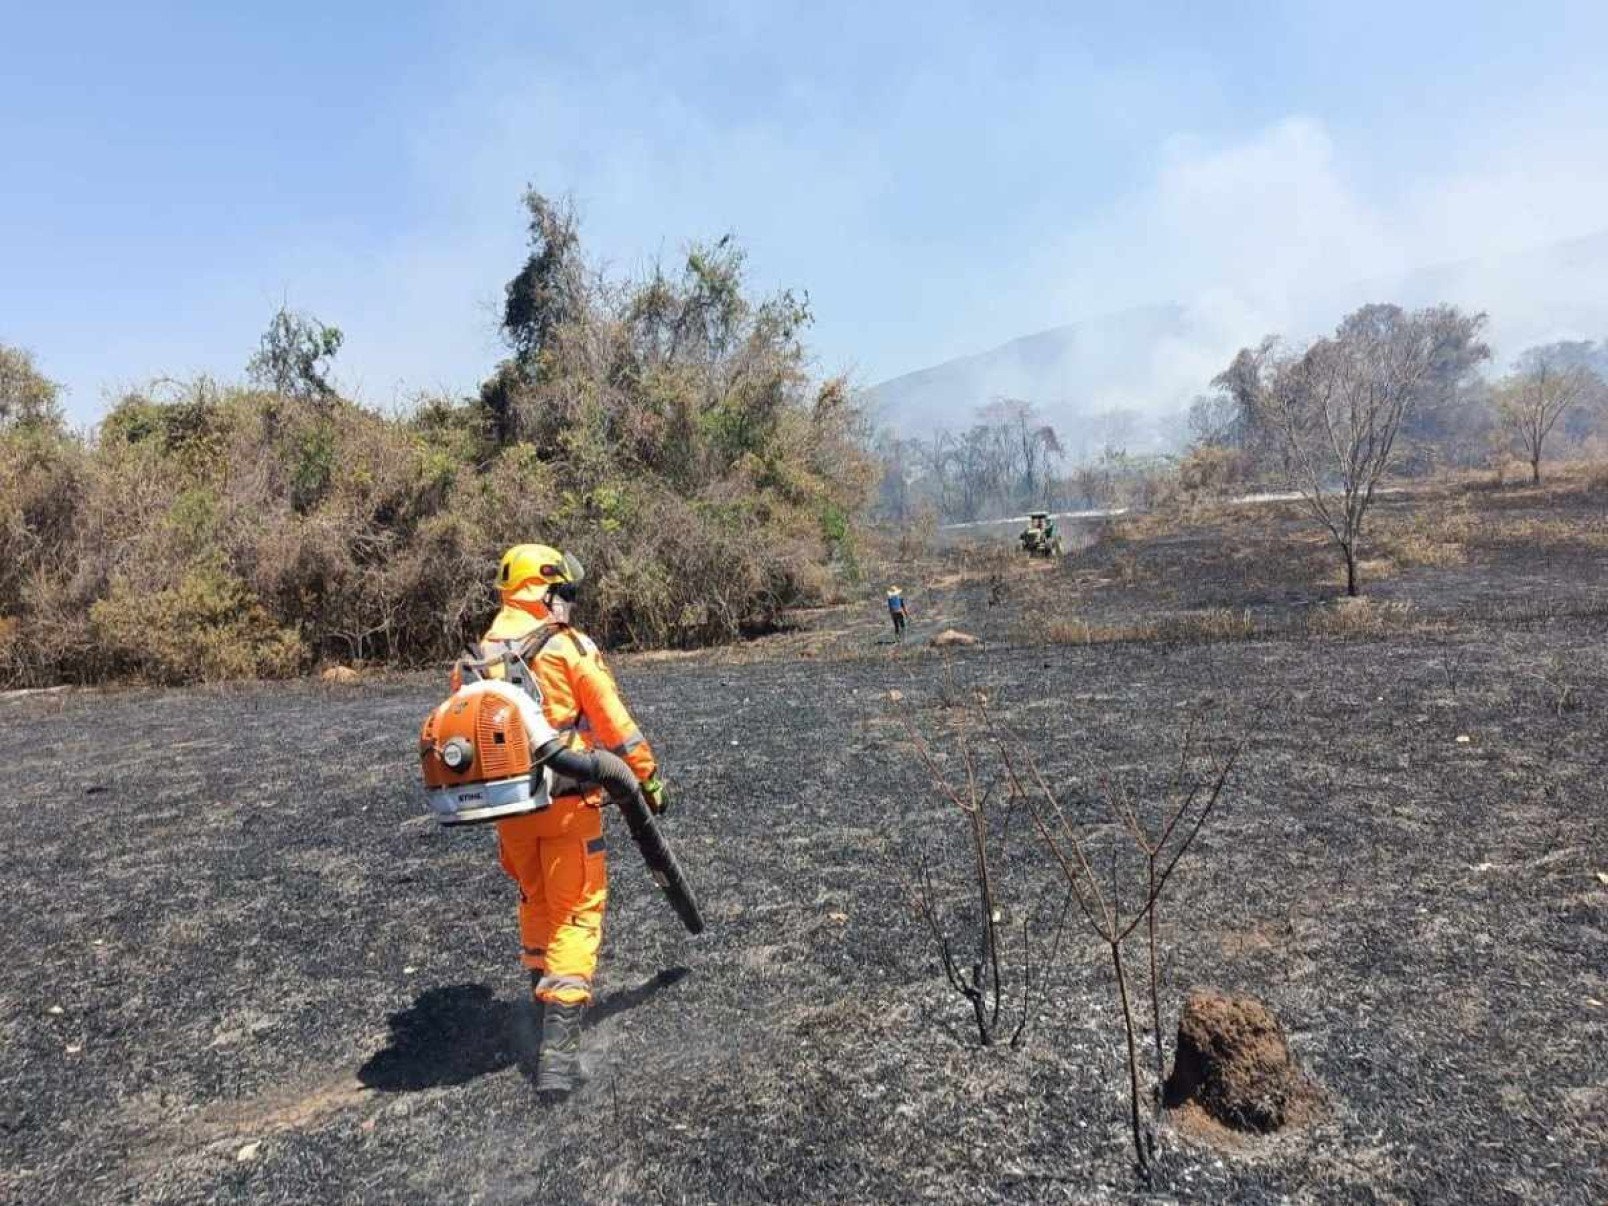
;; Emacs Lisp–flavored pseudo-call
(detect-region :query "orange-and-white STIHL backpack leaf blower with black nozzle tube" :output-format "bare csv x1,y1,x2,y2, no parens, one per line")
418,681,704,934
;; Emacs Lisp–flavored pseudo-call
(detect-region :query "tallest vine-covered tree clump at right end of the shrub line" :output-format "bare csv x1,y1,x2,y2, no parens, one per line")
478,190,872,643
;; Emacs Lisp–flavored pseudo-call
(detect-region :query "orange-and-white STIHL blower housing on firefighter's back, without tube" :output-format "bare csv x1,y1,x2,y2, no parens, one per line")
418,680,561,825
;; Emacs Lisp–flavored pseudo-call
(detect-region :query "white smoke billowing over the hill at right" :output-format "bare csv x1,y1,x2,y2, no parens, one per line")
867,119,1608,458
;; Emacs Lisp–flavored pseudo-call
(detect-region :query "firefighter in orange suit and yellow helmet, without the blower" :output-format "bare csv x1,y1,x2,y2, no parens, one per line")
453,545,666,1100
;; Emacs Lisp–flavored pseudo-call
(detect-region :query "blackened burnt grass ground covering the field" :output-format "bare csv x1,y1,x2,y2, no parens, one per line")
0,475,1608,1203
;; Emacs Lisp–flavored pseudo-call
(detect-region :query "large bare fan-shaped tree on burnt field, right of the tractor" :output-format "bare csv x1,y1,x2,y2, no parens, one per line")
1261,306,1484,595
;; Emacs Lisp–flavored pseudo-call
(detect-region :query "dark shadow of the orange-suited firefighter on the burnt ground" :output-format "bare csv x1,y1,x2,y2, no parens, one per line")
357,968,687,1093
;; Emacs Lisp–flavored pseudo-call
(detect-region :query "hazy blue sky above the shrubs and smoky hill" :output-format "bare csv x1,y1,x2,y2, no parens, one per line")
0,0,1608,420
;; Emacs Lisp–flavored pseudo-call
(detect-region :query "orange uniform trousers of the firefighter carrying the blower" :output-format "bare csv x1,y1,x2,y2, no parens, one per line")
497,796,608,1005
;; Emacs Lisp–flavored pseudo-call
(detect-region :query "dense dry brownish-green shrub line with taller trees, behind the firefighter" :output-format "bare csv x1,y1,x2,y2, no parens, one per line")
0,203,870,685
